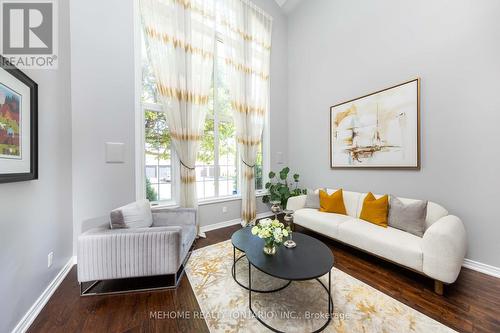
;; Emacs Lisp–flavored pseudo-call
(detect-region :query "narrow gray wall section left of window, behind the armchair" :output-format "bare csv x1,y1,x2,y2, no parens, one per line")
70,0,135,253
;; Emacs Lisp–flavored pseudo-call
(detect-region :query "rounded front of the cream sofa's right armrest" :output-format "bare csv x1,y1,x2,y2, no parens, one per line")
422,215,467,283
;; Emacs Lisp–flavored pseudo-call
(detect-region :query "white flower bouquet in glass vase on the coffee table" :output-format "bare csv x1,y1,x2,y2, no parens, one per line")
252,218,292,255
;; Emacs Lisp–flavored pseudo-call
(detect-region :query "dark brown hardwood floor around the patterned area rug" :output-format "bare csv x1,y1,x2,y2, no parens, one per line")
29,220,500,332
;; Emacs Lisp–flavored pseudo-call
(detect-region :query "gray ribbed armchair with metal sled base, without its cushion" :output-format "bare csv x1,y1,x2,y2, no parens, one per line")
77,208,197,295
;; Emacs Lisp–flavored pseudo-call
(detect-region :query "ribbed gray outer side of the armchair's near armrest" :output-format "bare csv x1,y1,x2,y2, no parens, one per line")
77,227,182,282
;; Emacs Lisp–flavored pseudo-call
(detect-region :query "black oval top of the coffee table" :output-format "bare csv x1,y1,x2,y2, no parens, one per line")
231,227,334,281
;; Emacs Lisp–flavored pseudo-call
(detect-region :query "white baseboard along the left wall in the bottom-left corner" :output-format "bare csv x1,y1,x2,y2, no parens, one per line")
12,257,76,333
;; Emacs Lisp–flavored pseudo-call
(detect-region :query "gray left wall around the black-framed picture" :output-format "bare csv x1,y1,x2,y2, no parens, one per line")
0,1,72,332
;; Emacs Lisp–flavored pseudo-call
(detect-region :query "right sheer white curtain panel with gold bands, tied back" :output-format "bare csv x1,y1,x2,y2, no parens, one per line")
216,0,272,226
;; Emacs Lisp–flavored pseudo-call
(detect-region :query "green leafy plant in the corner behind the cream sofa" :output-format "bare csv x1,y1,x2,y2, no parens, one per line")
262,167,306,208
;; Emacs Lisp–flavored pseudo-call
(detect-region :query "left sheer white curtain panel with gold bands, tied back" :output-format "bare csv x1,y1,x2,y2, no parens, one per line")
140,0,215,231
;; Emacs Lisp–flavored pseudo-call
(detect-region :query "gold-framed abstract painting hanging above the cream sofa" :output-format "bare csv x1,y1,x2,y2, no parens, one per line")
330,79,420,170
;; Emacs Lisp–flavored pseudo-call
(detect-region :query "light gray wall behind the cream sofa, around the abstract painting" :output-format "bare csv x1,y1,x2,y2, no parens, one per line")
288,0,500,267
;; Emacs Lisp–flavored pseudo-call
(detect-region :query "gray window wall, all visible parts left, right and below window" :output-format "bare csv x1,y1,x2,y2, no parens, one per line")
71,0,288,244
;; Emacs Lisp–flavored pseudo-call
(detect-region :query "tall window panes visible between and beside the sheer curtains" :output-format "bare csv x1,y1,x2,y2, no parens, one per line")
141,36,267,202
